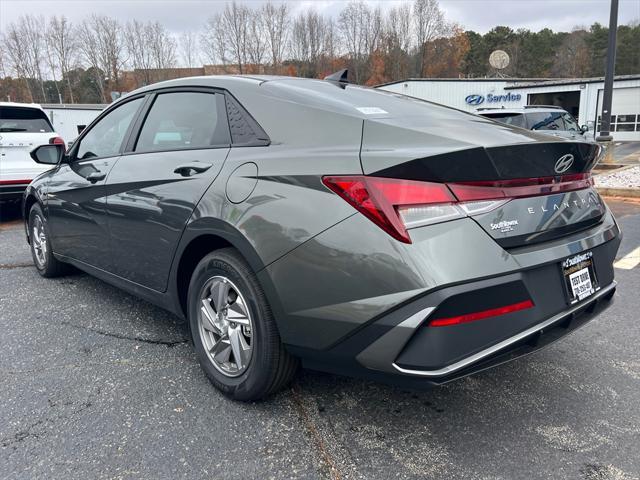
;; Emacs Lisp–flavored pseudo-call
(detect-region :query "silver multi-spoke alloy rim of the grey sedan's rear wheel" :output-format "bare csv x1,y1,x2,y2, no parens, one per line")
198,276,255,377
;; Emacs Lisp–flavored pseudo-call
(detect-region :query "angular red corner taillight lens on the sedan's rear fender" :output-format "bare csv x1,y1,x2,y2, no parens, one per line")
322,175,456,243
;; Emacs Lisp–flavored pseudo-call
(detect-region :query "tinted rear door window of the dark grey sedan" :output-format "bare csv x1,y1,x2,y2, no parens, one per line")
134,92,229,152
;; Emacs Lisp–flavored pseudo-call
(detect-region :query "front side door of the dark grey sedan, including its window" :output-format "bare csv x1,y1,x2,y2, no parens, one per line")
46,97,144,270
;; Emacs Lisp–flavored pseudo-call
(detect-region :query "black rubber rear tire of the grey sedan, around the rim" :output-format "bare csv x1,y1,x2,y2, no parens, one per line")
188,248,298,401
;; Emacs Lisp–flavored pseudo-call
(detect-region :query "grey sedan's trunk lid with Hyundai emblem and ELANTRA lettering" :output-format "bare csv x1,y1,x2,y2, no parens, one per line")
361,115,606,249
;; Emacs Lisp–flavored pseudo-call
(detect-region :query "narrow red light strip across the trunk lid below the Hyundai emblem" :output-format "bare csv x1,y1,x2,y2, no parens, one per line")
448,173,593,202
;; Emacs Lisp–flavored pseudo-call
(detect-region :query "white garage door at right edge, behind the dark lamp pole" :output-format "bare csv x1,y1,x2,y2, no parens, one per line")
598,87,640,141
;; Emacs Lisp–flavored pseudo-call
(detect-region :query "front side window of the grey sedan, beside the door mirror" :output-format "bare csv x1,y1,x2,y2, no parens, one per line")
76,97,144,160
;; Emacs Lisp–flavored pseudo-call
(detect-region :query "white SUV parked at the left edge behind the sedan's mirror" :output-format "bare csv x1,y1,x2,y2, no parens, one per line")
0,102,64,202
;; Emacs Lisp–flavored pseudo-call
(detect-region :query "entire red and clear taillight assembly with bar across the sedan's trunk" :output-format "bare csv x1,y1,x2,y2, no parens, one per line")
322,173,593,243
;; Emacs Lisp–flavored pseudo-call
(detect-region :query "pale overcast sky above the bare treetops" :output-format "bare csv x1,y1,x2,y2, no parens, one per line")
0,0,640,33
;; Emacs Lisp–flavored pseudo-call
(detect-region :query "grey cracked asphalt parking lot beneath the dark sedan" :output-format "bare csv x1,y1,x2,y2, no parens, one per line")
0,201,640,480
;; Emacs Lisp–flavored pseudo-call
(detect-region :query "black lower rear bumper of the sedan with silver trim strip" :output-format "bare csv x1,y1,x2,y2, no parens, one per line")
293,237,620,388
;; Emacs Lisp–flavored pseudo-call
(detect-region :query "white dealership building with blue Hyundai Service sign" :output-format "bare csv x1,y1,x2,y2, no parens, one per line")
378,75,640,141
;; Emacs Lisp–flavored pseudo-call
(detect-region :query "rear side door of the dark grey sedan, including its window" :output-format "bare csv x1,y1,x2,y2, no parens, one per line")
107,89,230,291
